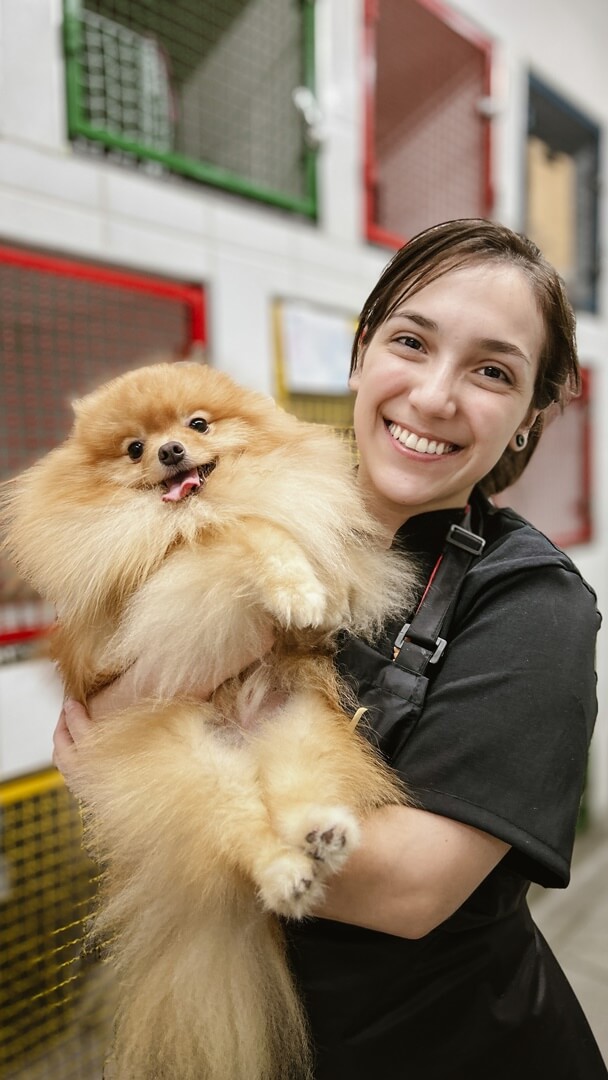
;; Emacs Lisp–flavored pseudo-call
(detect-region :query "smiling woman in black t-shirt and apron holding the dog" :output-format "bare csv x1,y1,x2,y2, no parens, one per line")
288,214,608,1080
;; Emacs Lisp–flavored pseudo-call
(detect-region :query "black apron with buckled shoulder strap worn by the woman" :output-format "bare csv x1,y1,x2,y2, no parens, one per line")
285,513,608,1080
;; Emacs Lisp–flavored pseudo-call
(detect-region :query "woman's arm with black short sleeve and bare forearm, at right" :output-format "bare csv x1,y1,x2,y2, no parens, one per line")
316,565,598,937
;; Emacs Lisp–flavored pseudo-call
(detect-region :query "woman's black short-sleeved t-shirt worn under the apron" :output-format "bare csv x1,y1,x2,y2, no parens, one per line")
392,494,599,886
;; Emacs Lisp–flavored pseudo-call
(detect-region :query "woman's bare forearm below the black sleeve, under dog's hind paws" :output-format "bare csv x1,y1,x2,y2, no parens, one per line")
315,806,509,937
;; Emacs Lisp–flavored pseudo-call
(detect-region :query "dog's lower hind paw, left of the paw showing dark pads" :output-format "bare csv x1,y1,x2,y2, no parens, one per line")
256,851,324,919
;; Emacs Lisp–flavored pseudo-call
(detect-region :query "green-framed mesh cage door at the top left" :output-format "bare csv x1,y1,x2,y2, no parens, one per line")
66,0,314,213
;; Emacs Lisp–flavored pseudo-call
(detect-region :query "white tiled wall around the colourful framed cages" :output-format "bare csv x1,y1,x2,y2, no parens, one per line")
0,0,608,813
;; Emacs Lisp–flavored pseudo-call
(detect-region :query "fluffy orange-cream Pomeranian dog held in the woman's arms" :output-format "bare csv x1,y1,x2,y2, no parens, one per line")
1,362,414,1080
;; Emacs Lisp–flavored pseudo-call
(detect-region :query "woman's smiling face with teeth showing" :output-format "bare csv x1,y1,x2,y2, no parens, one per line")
350,262,544,530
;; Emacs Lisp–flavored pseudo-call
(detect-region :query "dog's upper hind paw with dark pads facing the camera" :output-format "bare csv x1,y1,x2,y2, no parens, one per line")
280,806,361,878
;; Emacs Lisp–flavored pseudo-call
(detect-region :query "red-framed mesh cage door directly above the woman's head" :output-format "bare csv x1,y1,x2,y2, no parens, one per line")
368,0,488,244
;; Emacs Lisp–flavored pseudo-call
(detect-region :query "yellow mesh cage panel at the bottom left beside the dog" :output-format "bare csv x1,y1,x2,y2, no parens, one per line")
0,770,111,1080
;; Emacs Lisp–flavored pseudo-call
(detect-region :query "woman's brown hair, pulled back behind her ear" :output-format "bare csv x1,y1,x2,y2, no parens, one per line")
351,218,581,495
